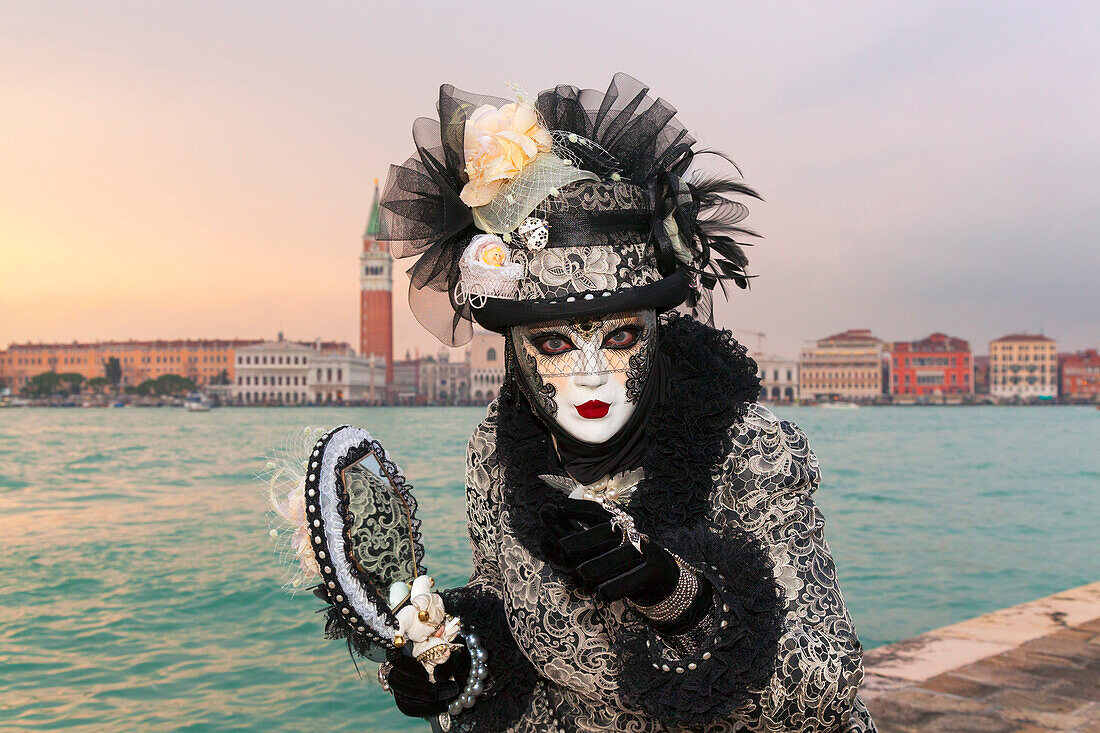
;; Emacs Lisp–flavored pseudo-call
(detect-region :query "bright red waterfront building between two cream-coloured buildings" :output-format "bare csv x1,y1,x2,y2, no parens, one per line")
890,333,974,397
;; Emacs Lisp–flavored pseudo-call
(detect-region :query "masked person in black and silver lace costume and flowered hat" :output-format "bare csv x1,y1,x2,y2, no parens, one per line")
382,75,875,732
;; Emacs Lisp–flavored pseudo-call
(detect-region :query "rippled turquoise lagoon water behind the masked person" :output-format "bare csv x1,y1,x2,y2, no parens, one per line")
0,407,1100,731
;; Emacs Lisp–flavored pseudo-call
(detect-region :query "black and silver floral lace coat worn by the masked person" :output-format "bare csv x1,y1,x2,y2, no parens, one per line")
446,403,876,733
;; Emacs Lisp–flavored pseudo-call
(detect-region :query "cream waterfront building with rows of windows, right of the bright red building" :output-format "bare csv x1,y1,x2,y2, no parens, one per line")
989,333,1058,400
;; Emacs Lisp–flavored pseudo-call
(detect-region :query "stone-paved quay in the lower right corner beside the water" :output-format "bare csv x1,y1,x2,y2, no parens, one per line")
862,582,1100,733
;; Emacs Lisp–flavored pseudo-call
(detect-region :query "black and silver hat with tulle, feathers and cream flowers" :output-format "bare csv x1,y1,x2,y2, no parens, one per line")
380,74,756,346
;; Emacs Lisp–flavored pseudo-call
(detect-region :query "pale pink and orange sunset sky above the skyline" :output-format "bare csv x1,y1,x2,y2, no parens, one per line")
0,0,1100,355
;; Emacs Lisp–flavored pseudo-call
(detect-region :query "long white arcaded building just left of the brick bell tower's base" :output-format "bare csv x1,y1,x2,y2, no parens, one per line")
232,333,386,405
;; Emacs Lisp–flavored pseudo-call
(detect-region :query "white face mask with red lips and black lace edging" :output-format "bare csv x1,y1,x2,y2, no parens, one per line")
509,310,657,444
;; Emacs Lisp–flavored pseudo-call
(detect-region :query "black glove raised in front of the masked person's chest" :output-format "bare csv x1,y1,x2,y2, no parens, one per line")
539,499,680,605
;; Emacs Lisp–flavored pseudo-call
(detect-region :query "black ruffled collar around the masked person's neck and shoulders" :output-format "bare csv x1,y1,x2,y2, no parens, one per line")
496,314,760,561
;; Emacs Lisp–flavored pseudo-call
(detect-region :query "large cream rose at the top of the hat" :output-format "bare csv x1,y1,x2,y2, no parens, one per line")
460,102,553,207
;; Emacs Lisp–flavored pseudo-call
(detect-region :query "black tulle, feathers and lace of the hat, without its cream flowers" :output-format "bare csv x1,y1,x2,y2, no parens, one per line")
378,74,757,346
